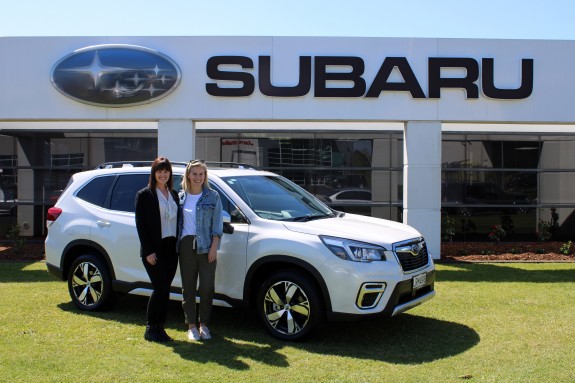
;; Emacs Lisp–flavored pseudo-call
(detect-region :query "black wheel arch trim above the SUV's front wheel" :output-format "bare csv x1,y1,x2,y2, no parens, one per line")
243,255,331,312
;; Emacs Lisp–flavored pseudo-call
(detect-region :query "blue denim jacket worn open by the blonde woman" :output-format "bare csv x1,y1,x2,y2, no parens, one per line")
178,188,224,254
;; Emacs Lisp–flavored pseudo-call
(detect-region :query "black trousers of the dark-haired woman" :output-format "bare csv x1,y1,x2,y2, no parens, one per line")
142,237,178,325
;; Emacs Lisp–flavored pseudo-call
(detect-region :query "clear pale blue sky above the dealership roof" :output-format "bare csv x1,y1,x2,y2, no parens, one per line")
0,0,575,40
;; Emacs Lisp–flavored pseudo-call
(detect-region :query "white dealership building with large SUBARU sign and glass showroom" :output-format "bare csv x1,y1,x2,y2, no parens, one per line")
0,37,575,257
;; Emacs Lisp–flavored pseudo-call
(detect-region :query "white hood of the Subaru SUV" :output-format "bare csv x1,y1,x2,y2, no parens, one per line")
284,214,421,246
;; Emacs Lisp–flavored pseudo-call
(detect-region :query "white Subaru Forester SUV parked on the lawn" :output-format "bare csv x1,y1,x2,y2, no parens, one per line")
45,163,435,340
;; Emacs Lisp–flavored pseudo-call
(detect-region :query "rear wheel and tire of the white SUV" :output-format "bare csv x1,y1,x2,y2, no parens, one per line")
68,254,114,311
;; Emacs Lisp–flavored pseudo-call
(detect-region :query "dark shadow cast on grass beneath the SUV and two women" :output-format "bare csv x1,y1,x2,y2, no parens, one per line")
60,296,480,370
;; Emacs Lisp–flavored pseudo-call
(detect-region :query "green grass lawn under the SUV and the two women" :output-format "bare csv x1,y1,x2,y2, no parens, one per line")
0,262,575,383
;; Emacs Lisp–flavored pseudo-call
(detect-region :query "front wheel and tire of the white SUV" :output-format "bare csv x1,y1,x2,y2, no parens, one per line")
257,270,323,341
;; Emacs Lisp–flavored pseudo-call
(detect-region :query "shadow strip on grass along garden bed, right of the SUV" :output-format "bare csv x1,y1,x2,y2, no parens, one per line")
436,262,575,283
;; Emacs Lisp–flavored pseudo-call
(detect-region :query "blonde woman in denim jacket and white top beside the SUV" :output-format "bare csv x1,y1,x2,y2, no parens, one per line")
178,160,223,340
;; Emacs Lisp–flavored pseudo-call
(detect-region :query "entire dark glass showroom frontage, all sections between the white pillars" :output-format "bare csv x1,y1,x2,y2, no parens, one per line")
0,129,575,241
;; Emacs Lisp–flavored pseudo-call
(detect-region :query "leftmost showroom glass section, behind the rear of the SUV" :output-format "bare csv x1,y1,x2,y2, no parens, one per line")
0,132,157,236
